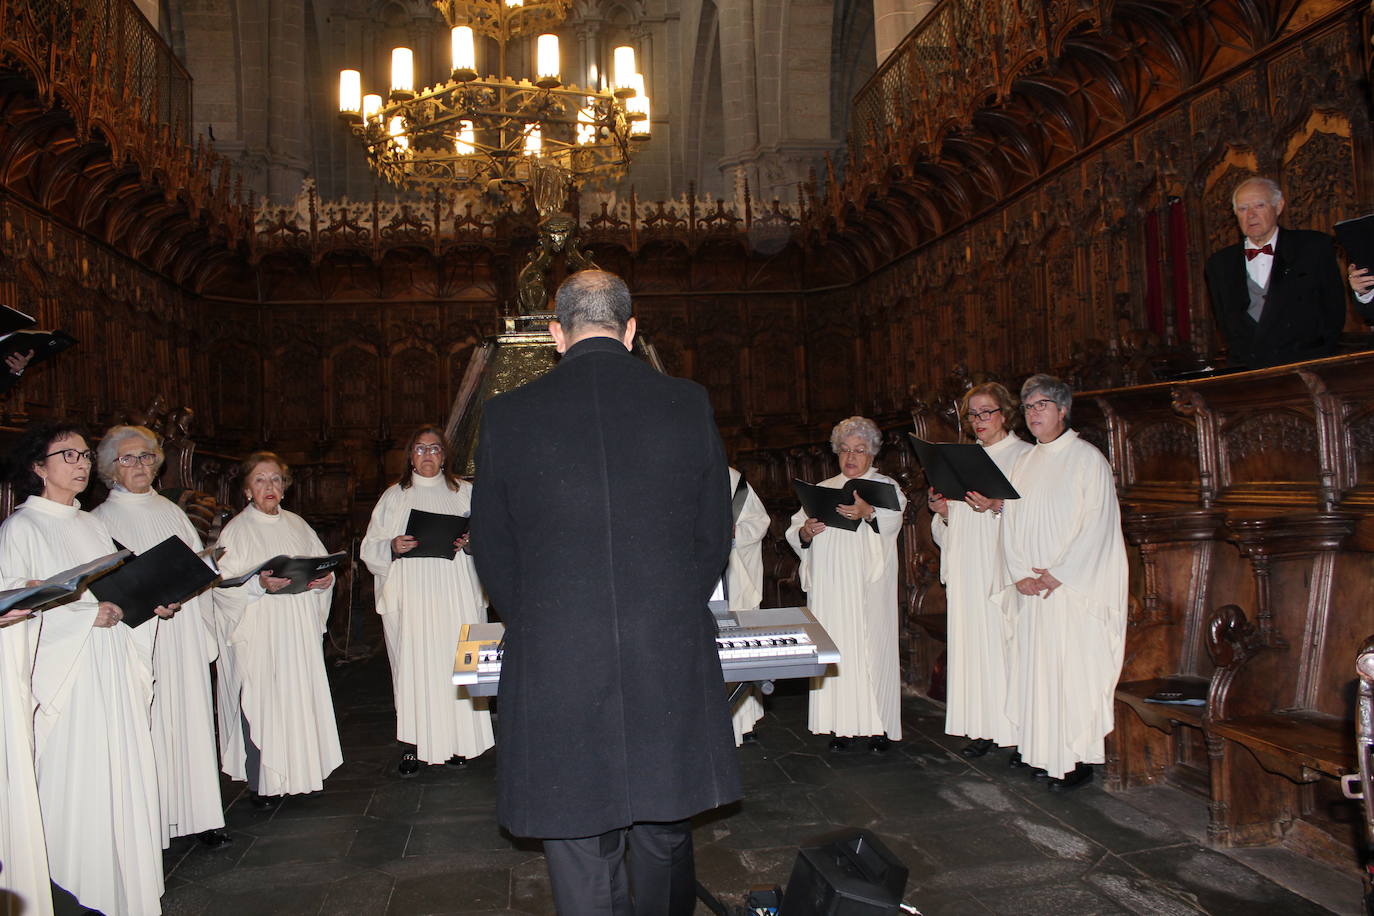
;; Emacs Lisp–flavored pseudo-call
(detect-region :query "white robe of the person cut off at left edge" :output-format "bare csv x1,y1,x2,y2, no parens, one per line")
0,590,52,916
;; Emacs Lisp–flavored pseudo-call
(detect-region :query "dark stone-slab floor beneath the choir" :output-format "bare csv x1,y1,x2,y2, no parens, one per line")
162,658,1360,916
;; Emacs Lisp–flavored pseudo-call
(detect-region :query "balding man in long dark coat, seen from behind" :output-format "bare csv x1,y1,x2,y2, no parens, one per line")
473,271,741,916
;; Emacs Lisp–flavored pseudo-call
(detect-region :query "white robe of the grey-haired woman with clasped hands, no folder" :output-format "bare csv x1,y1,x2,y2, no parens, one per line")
999,430,1127,777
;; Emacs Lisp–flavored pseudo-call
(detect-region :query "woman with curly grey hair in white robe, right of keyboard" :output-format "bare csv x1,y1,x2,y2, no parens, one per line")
787,416,907,753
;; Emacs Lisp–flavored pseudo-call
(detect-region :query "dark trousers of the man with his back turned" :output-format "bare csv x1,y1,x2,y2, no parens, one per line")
544,820,697,916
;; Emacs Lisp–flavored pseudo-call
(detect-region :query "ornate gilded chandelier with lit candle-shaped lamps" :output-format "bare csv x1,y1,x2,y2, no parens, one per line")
339,0,649,201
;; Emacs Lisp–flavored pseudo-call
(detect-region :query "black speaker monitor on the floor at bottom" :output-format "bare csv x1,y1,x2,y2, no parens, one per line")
780,829,907,916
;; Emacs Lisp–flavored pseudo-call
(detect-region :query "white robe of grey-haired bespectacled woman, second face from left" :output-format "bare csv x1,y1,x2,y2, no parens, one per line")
91,488,224,847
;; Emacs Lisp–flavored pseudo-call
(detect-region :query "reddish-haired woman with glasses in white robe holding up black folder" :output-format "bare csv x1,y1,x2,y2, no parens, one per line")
927,382,1031,758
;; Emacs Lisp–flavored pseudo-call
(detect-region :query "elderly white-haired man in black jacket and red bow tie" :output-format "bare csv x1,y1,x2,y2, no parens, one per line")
1206,177,1345,368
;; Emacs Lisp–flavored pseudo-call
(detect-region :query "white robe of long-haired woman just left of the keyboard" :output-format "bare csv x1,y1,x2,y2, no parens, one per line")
363,474,496,764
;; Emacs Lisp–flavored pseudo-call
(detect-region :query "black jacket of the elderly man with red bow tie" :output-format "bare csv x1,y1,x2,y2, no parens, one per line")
1206,228,1347,368
